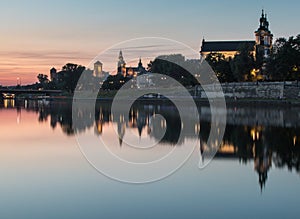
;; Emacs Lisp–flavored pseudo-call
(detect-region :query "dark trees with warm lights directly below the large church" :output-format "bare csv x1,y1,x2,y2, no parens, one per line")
206,35,300,82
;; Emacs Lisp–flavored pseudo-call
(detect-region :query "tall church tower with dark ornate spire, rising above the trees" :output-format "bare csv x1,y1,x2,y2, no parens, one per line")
255,10,273,58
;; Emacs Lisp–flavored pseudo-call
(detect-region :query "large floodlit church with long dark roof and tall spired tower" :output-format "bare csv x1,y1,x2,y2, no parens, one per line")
200,10,273,58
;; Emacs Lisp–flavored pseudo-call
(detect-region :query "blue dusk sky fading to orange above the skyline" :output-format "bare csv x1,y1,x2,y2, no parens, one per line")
0,0,300,86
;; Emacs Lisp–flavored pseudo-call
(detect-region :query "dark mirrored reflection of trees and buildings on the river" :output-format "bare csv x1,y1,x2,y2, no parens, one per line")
0,100,300,189
